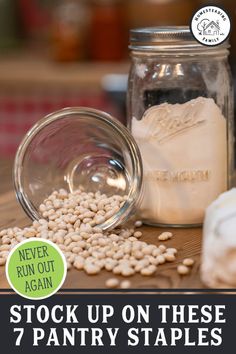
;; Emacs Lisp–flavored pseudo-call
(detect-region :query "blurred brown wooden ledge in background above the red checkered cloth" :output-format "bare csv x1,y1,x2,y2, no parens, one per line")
0,51,130,93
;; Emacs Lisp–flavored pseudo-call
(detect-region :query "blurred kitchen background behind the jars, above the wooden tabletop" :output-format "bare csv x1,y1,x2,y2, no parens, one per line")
0,0,236,158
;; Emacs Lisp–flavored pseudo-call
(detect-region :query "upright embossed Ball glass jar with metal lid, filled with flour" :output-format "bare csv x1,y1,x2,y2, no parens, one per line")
128,27,234,227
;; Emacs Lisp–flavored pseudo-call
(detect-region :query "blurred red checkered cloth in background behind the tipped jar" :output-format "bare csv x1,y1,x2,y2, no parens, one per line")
0,92,120,157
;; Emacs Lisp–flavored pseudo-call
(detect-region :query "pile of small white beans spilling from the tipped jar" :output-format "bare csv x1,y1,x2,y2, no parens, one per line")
0,189,181,277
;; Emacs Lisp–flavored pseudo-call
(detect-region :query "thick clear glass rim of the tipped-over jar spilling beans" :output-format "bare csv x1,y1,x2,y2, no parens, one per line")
13,107,143,230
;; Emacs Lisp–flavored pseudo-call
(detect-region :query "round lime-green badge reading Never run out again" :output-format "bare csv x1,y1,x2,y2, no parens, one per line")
6,238,67,300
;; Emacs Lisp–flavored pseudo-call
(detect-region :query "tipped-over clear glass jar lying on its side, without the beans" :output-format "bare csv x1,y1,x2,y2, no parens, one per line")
13,107,142,230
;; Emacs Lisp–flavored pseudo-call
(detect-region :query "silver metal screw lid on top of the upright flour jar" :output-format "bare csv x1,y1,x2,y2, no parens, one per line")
129,26,229,51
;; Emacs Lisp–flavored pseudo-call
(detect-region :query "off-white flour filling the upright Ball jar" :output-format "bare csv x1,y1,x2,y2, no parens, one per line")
132,97,227,225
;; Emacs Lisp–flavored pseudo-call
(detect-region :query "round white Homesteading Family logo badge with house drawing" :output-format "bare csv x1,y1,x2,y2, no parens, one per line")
190,6,231,46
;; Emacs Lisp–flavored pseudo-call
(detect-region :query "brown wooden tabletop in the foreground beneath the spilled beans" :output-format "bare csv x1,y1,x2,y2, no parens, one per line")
0,160,203,289
